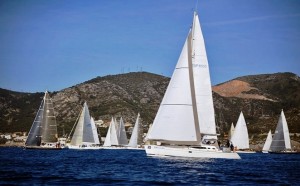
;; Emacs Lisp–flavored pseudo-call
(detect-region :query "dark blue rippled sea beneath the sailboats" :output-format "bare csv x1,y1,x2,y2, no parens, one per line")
0,147,300,185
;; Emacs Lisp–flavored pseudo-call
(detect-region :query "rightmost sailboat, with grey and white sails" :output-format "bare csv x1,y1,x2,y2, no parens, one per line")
269,110,296,153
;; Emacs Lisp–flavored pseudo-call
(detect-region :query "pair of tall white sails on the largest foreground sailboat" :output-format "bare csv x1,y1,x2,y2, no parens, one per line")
147,12,216,145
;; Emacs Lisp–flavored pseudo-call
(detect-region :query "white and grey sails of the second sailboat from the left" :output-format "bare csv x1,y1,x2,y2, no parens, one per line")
71,102,96,146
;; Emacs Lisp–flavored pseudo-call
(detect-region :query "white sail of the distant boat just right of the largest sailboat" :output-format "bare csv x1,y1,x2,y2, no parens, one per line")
231,112,249,149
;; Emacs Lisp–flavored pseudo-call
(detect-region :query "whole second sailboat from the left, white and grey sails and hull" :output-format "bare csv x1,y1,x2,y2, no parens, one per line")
67,102,100,150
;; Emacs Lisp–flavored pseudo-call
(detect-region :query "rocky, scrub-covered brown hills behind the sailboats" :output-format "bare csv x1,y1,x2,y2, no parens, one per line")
0,72,300,144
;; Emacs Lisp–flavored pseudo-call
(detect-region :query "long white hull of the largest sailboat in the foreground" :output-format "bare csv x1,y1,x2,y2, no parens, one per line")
145,145,241,159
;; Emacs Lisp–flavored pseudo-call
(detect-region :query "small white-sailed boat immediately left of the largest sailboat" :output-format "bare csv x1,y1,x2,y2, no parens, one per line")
128,113,144,150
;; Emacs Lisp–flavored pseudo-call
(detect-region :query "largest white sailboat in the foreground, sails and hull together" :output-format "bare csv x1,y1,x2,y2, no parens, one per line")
145,12,240,159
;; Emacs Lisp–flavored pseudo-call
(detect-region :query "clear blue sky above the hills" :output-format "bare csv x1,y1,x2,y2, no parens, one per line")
0,0,300,92
